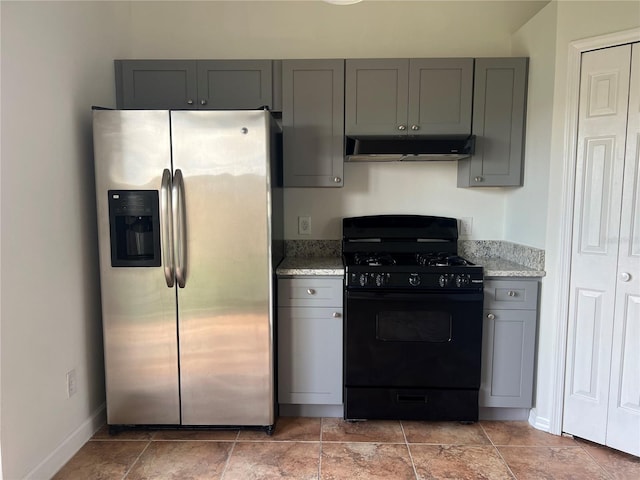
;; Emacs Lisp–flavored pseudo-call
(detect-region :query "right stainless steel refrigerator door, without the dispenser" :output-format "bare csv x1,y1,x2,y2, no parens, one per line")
171,111,274,426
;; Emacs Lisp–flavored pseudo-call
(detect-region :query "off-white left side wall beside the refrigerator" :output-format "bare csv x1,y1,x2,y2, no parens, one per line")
0,1,129,480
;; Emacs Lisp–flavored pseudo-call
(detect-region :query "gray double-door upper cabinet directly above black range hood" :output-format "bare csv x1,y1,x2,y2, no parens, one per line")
345,58,473,135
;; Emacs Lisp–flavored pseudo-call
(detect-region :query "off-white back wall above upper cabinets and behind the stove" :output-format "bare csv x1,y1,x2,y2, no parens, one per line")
126,2,544,240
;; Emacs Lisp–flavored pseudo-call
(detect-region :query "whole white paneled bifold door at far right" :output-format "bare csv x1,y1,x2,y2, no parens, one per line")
563,45,640,455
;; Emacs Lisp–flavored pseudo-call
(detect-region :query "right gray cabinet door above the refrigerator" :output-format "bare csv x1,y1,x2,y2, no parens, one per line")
198,60,273,110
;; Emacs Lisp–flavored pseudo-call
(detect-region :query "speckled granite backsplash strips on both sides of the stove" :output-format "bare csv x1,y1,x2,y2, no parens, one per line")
285,240,544,270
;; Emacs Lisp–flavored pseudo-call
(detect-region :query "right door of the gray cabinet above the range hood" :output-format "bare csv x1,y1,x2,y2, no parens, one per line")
407,58,473,135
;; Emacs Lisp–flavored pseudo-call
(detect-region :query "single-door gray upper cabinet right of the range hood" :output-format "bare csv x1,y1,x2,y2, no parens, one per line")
458,58,528,187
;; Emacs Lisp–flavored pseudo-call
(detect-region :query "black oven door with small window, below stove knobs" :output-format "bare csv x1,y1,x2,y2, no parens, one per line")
344,290,483,389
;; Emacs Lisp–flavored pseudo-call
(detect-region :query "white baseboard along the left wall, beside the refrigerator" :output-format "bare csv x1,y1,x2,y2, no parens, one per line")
24,403,107,480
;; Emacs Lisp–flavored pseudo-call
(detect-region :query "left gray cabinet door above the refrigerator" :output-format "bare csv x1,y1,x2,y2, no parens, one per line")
115,60,198,110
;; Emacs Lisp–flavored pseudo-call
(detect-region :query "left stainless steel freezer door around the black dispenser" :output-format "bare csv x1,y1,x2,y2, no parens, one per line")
93,110,180,425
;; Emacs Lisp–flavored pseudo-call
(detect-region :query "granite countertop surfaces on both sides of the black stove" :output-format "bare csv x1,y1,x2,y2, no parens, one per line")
276,257,546,277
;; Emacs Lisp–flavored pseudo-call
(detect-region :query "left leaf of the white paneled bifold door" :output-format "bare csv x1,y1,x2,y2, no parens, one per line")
563,45,631,443
